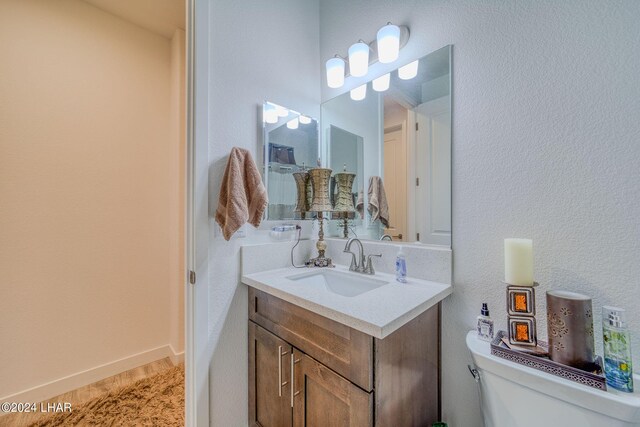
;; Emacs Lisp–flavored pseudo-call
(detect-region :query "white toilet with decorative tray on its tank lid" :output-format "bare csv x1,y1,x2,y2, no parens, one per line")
467,331,640,427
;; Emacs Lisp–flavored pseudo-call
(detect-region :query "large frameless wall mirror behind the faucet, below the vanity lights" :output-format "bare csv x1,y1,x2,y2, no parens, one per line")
320,46,452,247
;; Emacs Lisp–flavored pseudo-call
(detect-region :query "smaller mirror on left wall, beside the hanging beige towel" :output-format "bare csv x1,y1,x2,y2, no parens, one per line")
262,102,320,220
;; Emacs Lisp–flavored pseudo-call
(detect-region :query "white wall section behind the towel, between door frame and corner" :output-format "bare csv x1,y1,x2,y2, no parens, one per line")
209,0,320,427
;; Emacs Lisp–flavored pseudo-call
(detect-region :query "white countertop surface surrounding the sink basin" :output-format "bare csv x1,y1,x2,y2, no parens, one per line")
242,265,453,339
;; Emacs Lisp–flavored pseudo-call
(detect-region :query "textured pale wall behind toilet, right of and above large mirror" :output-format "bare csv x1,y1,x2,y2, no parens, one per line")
320,0,640,427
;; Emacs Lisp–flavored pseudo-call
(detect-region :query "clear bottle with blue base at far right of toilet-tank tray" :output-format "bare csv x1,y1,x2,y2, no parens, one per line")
602,306,633,393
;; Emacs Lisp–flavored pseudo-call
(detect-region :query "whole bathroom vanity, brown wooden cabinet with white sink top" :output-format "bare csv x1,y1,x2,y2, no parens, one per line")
242,266,451,427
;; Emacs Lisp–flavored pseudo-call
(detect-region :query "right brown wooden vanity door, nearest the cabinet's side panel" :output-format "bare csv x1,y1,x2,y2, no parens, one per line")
293,349,373,427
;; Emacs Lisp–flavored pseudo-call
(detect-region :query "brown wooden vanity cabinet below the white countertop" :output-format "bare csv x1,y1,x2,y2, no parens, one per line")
249,288,440,427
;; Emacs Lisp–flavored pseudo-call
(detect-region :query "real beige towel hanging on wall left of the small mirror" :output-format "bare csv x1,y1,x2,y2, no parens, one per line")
216,147,269,240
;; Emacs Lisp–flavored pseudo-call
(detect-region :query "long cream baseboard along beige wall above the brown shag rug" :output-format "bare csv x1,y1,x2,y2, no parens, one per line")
0,344,176,408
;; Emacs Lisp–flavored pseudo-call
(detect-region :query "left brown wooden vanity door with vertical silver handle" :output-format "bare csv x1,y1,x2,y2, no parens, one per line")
249,322,292,427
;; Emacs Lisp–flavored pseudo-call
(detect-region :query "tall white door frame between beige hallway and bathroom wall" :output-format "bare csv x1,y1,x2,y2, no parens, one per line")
185,0,209,426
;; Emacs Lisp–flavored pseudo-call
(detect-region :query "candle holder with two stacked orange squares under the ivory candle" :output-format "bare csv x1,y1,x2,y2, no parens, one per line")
507,282,538,347
